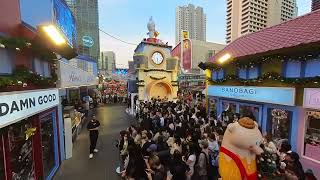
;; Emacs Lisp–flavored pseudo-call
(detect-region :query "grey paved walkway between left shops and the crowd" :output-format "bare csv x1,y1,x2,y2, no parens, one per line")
54,105,131,180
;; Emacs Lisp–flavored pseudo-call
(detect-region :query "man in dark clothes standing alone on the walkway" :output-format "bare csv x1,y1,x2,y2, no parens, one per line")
87,115,100,159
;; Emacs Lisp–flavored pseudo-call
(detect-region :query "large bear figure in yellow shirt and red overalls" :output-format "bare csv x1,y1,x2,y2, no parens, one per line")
219,117,263,180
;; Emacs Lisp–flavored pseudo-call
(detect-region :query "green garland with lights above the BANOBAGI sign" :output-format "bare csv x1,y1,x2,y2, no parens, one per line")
211,72,320,86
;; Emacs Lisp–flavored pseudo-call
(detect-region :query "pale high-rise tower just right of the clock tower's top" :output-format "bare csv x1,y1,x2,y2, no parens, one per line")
176,4,206,44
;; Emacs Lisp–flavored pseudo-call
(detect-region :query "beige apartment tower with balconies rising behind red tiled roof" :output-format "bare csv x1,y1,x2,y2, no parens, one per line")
226,0,298,43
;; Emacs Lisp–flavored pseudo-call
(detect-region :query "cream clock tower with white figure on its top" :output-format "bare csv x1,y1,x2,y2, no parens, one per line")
133,17,178,101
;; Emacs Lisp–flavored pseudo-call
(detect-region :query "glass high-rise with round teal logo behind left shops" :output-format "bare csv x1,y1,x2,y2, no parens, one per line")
66,0,100,61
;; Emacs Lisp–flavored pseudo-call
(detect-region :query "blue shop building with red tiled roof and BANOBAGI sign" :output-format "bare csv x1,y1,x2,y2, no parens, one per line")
206,11,320,179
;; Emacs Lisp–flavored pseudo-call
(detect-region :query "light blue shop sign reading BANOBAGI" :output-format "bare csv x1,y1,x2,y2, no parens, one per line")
208,86,295,106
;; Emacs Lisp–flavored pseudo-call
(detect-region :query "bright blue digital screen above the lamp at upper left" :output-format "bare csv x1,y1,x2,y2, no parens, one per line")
53,0,77,47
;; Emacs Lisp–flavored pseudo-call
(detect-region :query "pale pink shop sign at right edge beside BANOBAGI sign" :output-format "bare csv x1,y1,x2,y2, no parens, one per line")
303,88,320,109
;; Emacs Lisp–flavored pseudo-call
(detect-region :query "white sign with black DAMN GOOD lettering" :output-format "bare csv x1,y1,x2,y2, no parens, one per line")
0,89,59,128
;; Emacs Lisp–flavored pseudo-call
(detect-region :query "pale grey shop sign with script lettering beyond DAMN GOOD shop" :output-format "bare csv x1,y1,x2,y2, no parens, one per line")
59,61,98,88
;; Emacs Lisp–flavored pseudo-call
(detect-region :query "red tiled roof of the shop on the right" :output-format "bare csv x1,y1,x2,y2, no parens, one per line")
210,10,320,62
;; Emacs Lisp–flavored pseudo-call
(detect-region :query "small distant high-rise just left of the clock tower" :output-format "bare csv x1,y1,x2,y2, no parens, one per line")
98,51,116,74
